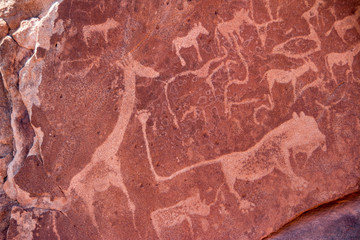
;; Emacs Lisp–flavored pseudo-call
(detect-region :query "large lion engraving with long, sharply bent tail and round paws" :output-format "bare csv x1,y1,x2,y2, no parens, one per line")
138,111,326,211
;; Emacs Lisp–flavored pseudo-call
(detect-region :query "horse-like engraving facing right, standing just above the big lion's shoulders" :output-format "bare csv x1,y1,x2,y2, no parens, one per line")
261,60,318,102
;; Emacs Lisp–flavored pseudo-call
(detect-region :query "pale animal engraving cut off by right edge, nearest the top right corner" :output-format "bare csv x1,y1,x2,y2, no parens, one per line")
325,7,360,43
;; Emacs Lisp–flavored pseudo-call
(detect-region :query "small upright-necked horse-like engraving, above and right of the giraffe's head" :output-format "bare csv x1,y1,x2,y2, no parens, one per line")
172,23,209,66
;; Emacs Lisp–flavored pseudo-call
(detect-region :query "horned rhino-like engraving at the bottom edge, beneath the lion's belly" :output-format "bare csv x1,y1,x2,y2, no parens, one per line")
151,186,221,239
